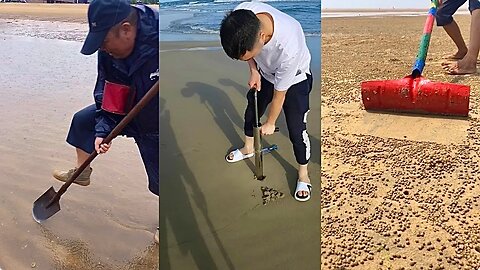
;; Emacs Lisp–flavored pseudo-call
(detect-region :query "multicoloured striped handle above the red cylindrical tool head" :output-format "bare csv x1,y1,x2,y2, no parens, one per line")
412,0,439,78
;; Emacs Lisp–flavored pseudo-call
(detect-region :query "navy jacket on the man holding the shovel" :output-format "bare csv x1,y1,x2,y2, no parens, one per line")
93,5,160,138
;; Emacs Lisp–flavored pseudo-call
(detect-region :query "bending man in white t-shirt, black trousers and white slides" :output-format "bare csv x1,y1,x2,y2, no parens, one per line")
220,2,313,201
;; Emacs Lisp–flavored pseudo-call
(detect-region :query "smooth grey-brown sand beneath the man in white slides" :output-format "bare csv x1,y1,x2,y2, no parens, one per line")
160,39,320,269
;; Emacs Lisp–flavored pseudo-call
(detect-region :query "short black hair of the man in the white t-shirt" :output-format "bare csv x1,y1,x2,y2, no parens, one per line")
220,9,260,59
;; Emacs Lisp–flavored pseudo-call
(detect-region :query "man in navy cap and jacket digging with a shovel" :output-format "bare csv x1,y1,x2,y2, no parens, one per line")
53,0,160,243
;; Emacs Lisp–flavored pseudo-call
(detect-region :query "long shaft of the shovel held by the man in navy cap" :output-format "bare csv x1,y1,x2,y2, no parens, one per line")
47,81,159,208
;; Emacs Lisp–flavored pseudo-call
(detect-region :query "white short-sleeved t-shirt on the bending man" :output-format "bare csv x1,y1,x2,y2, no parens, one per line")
235,2,311,91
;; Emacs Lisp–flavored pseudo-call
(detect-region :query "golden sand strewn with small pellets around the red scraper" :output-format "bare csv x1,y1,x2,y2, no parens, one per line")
321,15,480,270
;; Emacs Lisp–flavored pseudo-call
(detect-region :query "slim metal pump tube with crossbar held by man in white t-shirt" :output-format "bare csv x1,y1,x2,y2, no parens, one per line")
250,88,279,181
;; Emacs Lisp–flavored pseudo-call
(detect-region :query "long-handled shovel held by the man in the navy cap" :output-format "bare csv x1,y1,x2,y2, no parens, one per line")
32,81,159,223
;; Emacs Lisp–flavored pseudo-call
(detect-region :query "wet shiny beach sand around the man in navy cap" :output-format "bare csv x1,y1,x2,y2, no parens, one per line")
0,3,159,270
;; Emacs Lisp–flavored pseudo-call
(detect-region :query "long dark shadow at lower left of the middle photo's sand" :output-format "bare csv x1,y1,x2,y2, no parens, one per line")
160,98,235,270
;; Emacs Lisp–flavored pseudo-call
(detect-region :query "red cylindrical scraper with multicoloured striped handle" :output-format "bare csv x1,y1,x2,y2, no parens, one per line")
361,0,470,116
